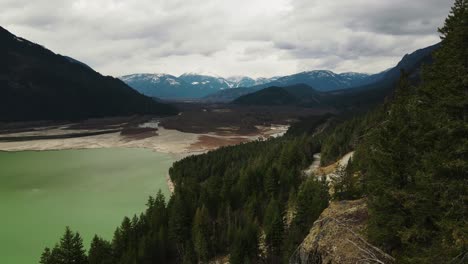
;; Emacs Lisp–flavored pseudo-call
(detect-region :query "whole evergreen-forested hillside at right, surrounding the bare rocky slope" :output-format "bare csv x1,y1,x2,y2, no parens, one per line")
41,0,468,264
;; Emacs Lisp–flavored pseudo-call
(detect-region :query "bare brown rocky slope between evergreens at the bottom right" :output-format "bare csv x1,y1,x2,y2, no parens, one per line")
290,199,394,264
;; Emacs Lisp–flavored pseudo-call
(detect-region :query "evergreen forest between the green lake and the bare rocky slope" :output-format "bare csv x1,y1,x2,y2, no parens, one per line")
43,116,329,264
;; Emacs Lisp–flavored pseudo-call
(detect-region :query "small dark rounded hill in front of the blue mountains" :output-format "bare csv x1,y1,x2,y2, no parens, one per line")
232,84,326,107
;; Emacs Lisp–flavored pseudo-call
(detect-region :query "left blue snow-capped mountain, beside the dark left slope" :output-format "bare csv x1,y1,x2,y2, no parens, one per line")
120,73,277,99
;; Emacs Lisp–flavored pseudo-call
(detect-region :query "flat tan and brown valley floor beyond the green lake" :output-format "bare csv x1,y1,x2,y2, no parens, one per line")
0,118,288,157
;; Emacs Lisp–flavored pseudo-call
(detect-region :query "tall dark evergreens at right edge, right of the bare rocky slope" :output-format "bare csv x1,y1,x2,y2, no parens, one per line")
355,0,468,263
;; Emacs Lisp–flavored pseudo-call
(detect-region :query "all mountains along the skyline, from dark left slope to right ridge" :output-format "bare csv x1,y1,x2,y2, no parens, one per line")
0,24,439,122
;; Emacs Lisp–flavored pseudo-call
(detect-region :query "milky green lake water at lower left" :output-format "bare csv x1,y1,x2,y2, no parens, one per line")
0,149,174,264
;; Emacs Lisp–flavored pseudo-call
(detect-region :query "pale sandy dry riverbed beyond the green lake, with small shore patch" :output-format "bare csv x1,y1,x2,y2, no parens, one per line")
0,116,288,195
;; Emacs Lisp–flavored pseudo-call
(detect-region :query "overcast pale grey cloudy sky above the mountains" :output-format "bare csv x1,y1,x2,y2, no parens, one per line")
0,0,453,77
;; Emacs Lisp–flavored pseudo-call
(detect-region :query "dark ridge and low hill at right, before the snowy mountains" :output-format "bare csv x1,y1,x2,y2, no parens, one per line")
231,44,439,110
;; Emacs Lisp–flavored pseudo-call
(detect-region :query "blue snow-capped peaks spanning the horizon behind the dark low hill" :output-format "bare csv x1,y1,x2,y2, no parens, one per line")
120,70,375,99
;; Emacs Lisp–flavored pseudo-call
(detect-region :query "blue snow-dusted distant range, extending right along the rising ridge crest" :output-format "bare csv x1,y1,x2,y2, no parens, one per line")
120,42,431,102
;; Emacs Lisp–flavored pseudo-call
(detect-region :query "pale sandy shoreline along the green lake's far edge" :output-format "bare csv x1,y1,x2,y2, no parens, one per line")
0,125,289,194
